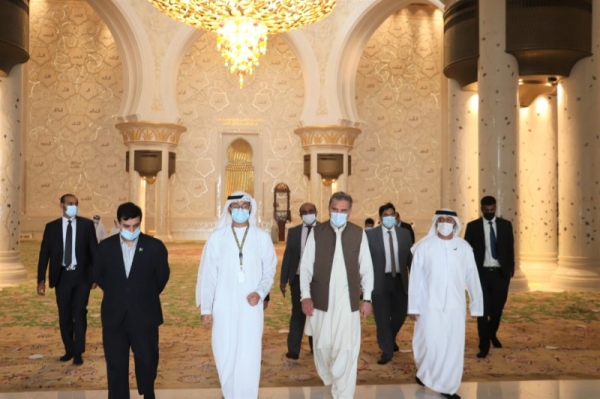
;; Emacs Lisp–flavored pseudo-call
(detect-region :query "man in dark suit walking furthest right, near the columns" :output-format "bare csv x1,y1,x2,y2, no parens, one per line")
465,196,515,358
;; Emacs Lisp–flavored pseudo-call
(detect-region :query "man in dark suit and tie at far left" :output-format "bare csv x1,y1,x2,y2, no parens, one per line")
37,194,98,366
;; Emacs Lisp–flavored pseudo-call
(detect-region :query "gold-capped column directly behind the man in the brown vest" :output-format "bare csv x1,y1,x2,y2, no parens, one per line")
294,126,361,216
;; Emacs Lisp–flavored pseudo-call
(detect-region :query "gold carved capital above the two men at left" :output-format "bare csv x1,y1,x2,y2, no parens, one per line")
115,122,187,145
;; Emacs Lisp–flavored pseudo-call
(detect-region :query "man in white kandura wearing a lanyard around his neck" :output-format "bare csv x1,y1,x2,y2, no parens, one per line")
196,191,277,399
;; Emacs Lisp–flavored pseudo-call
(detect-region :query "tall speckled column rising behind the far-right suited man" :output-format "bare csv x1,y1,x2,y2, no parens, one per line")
478,1,528,291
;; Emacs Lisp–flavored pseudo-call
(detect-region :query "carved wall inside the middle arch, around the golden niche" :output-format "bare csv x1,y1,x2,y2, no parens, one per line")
171,33,308,222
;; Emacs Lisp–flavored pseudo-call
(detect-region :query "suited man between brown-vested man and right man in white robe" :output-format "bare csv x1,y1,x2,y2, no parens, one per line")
366,203,412,364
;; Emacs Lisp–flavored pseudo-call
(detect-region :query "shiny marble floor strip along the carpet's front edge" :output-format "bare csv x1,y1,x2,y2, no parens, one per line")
0,380,600,399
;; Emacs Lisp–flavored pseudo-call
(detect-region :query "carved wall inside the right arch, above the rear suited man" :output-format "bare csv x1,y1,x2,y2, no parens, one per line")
348,5,443,223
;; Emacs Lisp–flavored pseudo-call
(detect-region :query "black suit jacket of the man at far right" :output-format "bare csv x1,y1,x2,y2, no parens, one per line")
465,217,515,277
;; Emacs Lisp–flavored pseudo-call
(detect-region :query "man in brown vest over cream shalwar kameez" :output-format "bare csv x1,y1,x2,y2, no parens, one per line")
300,192,373,398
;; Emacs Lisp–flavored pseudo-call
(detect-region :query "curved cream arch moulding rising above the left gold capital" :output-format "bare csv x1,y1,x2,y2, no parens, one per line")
87,0,154,121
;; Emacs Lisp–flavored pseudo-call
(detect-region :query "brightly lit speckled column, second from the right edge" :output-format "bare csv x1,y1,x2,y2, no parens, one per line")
516,96,558,288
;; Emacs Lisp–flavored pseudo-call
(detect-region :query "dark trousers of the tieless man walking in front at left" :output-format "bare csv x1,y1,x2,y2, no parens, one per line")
102,317,158,399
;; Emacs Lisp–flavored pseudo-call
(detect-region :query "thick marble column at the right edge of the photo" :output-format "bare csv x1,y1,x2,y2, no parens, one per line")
550,26,600,291
